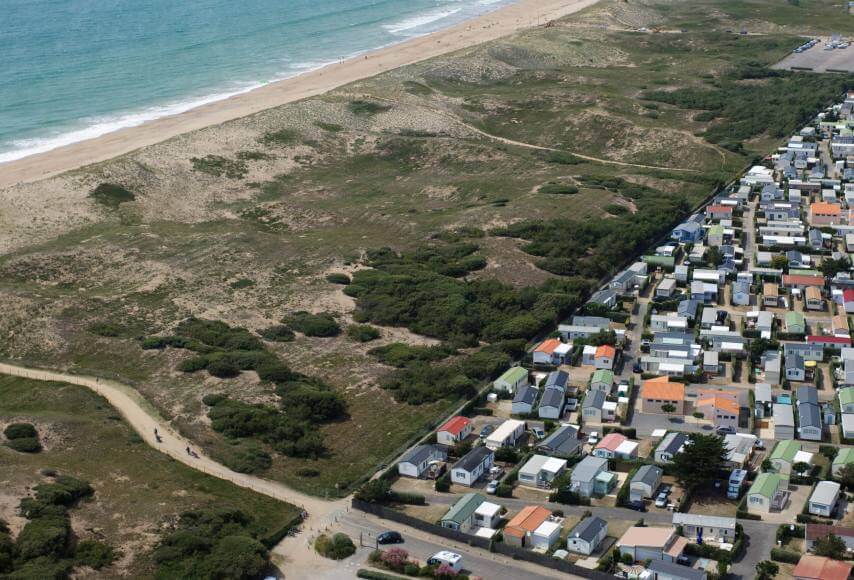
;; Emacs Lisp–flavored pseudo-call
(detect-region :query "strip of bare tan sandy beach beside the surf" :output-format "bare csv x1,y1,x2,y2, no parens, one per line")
0,0,598,187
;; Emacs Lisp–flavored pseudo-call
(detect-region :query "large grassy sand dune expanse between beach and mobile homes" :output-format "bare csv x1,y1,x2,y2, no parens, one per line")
0,0,838,495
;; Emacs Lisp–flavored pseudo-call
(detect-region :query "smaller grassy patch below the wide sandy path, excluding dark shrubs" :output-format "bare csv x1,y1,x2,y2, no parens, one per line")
0,377,298,578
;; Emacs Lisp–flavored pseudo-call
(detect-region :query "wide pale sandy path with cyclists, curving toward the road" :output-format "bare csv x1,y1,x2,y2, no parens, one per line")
0,363,349,540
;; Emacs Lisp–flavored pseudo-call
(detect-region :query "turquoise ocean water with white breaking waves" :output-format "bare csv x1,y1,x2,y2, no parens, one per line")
0,0,513,163
